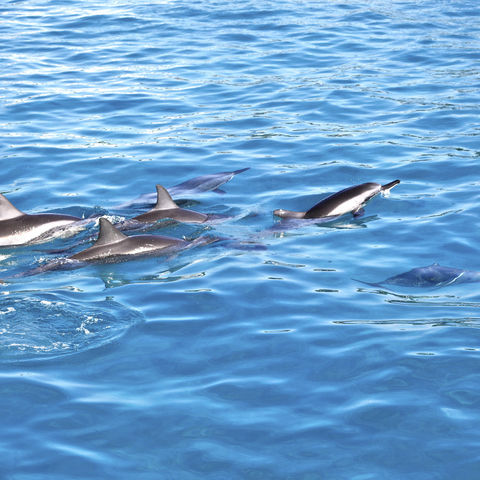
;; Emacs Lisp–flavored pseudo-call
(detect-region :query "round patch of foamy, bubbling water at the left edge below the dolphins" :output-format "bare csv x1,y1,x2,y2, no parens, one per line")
0,293,142,362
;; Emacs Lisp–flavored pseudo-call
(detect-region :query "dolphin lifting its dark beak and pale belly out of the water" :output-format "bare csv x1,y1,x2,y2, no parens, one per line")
273,180,400,219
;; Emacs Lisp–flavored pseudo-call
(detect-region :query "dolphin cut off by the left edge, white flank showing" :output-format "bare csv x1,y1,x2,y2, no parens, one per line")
0,194,81,247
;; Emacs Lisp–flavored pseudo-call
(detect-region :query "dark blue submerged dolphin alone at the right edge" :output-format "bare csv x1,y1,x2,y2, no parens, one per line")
359,263,480,287
